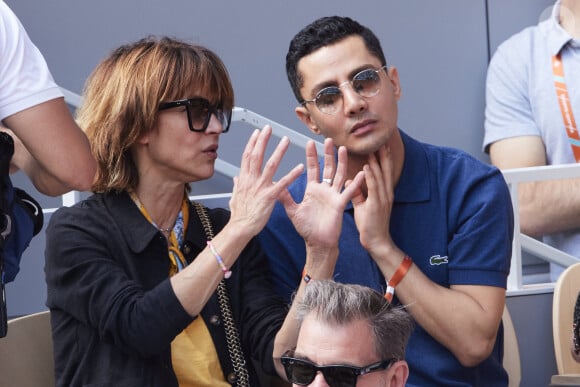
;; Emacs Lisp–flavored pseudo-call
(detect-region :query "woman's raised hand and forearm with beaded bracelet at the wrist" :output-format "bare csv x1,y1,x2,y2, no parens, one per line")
171,127,303,316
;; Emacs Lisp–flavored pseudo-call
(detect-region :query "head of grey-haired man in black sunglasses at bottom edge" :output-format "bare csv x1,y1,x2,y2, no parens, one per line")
281,280,414,387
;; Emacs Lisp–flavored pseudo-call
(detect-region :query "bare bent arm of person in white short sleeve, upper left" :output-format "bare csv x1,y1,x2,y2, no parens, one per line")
3,98,96,196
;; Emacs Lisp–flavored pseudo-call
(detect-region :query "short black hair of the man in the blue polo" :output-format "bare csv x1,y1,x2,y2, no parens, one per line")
286,16,387,103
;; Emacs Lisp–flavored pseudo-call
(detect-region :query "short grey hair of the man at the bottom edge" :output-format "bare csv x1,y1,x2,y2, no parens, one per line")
296,280,415,360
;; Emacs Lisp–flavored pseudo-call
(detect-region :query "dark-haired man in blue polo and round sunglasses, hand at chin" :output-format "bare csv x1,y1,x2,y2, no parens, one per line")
260,17,513,387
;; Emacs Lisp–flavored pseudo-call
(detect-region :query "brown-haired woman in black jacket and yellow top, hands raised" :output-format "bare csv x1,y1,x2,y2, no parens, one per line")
46,38,310,387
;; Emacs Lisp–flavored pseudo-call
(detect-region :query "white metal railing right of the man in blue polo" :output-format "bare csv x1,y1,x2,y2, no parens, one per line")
503,164,580,295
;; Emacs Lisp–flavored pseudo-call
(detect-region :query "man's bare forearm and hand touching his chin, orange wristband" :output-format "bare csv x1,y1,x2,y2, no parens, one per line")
353,147,505,367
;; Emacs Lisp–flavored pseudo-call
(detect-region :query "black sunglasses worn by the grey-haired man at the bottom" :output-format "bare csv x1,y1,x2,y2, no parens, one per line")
280,352,397,387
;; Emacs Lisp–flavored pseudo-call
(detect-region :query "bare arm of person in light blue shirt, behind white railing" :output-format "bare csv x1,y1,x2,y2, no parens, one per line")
489,136,580,237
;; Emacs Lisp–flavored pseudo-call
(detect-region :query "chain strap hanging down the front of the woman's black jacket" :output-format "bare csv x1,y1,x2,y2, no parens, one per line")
192,202,250,387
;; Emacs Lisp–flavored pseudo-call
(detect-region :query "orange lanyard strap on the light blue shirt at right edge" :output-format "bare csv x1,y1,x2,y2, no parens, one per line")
552,54,580,162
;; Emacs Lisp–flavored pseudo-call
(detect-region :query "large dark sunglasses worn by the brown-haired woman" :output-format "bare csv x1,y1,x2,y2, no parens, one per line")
159,97,232,133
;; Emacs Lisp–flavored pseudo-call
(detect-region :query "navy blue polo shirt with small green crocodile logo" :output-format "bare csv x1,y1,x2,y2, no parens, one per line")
260,131,513,387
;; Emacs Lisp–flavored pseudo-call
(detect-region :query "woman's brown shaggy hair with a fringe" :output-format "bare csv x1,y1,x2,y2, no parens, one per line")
77,37,234,192
